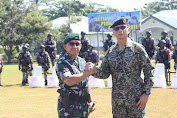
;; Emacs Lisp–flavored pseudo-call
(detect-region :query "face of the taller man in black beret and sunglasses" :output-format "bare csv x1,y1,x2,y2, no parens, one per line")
113,24,130,40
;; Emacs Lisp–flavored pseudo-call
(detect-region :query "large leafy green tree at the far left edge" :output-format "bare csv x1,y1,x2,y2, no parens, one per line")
0,0,51,62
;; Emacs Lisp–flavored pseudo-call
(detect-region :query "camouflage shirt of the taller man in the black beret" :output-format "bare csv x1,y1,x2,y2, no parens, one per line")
93,40,154,109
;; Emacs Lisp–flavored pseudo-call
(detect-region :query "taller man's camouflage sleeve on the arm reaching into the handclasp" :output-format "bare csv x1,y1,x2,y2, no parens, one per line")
93,54,110,79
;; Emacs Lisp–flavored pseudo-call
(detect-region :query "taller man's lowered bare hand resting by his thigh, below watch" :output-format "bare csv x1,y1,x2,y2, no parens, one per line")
136,93,149,110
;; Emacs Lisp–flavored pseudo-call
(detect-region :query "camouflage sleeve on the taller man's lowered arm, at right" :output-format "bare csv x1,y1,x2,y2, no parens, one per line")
139,47,154,92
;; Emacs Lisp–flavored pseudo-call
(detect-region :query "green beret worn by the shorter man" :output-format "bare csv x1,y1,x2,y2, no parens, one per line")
63,33,81,44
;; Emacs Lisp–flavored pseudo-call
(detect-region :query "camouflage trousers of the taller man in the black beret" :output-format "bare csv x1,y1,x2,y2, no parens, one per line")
113,105,146,118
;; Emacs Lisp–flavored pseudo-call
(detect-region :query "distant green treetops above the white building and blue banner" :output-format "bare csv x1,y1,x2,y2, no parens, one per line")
42,0,118,20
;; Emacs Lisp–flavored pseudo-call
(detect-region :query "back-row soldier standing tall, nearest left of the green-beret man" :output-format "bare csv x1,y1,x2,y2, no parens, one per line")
45,33,56,66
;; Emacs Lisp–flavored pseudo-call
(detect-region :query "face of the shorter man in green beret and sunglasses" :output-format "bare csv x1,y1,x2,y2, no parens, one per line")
63,40,82,57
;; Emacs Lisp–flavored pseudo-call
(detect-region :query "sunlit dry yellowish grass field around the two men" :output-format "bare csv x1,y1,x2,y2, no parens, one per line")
0,61,177,118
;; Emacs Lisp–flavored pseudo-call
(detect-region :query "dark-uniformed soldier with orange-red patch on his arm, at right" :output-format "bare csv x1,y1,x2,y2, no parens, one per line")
155,40,170,82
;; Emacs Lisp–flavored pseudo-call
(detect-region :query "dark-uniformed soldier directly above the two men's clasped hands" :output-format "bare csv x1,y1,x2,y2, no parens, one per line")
84,45,98,65
